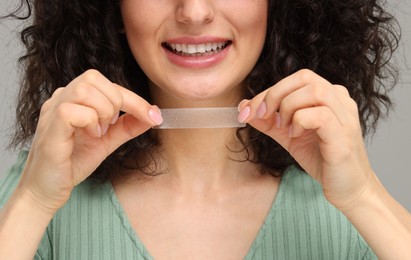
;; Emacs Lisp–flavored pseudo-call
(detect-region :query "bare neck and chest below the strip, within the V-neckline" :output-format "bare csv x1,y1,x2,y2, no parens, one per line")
113,130,280,259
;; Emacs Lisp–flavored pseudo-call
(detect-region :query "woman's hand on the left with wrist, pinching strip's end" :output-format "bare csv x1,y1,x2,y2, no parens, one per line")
18,70,162,214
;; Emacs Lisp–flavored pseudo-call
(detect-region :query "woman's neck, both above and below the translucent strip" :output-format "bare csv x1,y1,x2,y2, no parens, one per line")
142,81,257,191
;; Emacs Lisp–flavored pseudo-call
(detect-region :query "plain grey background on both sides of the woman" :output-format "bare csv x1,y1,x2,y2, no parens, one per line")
0,0,411,211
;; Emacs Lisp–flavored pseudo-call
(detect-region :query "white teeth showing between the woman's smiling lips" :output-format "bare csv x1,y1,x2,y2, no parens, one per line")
161,41,232,57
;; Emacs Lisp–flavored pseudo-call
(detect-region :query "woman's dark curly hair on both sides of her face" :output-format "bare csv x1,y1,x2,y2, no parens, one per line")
4,0,400,180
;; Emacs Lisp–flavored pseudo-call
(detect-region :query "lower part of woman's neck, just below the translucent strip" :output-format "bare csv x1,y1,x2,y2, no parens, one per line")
157,128,257,192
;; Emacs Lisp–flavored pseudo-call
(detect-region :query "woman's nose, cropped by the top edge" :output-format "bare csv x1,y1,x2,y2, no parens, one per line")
176,0,215,25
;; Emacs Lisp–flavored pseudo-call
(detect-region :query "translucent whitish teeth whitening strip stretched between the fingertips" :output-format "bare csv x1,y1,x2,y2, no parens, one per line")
154,107,245,129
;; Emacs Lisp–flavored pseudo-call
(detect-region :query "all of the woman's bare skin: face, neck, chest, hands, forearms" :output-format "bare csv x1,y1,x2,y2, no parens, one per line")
0,0,411,259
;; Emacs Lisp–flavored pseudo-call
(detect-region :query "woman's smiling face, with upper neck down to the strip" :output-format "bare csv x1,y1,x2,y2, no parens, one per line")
121,0,268,107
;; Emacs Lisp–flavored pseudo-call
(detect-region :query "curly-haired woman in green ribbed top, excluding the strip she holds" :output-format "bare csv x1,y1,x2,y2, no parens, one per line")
0,0,411,259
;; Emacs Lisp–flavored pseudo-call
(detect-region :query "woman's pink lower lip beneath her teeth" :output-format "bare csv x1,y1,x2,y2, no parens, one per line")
163,44,231,68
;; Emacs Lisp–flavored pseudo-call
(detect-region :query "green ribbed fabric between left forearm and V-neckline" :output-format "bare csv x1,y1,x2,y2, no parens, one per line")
42,179,145,259
